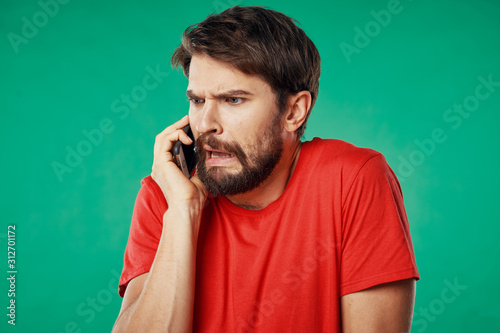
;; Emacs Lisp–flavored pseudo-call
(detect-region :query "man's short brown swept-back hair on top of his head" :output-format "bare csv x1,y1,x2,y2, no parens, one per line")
172,6,320,138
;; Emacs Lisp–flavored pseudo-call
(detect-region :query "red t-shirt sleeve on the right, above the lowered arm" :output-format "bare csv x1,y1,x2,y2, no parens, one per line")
340,153,420,296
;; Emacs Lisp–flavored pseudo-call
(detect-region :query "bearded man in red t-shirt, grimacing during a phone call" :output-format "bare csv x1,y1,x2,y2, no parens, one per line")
114,7,419,333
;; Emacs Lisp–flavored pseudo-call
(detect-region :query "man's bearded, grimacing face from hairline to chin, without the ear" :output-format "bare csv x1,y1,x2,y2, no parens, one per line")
187,55,283,196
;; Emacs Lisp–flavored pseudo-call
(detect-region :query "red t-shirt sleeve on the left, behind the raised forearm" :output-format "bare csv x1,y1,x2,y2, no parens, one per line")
118,176,167,297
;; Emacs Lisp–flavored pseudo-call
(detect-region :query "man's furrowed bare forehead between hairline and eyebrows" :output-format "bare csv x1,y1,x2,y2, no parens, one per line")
188,54,272,94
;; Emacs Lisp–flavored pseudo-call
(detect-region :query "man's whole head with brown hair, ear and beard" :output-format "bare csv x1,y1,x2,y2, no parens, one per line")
172,7,320,196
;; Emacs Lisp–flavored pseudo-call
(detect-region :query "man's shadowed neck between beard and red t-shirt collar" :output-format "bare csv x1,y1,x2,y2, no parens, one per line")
227,140,302,210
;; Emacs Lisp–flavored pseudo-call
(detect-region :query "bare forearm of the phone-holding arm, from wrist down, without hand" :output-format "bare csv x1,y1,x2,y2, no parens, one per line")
115,207,201,332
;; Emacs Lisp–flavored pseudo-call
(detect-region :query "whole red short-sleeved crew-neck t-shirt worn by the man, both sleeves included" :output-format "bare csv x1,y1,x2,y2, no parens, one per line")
119,138,420,333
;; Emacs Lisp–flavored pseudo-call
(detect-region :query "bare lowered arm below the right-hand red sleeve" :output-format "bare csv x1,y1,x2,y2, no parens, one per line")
340,278,415,333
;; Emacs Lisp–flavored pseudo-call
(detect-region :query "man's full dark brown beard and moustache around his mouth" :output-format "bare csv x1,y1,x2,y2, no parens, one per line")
196,115,283,196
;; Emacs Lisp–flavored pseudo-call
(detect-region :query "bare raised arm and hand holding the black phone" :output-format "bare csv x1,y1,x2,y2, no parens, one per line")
113,117,207,332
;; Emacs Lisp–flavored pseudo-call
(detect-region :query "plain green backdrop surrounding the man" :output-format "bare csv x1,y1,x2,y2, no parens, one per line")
0,0,500,333
